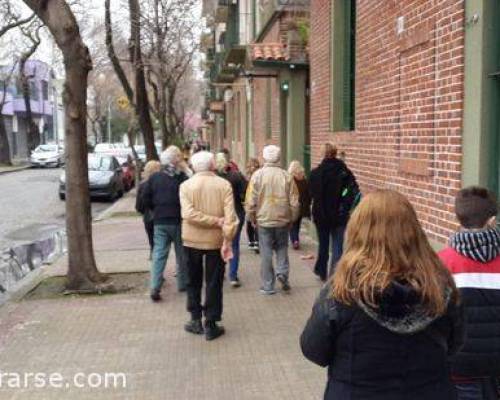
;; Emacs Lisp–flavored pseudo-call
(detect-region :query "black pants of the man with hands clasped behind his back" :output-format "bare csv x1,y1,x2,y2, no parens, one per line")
184,247,225,321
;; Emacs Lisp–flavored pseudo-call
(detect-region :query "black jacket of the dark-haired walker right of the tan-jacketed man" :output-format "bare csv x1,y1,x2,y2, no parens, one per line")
309,158,354,226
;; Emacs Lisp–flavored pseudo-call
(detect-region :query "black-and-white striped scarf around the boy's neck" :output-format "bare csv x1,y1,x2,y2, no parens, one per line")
450,228,500,263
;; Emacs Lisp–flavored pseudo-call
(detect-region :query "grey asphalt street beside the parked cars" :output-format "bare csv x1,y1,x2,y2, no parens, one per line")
0,169,111,249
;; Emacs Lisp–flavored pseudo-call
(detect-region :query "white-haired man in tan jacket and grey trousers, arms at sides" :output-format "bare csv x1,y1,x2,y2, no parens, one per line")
246,145,300,294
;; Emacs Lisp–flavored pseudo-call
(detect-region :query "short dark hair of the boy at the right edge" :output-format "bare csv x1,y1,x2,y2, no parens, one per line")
455,186,498,229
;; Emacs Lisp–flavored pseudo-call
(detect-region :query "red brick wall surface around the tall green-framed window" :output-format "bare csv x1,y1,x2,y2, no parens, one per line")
310,0,464,242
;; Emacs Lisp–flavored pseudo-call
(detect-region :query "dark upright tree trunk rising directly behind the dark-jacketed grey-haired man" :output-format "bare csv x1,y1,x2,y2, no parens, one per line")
129,0,158,160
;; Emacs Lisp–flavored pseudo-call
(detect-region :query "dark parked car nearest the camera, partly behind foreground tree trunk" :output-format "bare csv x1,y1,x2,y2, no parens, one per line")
59,154,124,200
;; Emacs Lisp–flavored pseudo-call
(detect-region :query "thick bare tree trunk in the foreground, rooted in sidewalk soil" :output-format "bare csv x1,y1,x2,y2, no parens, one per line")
24,0,104,290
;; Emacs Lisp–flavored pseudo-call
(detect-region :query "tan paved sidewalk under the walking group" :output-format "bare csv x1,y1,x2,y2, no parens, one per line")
0,192,326,400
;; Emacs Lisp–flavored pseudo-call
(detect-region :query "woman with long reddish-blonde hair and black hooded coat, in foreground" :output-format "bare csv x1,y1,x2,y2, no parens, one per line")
301,190,464,400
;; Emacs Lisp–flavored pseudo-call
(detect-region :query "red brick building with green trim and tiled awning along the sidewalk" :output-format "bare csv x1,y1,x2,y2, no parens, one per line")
205,0,500,246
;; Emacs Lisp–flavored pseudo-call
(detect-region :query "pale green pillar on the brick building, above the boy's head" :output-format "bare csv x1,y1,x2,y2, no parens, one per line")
462,0,500,200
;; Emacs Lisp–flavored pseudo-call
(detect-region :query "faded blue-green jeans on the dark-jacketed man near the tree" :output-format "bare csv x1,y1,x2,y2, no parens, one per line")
151,224,187,290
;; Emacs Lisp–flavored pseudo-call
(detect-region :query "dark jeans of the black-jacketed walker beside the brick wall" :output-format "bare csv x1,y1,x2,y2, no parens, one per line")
314,225,345,280
